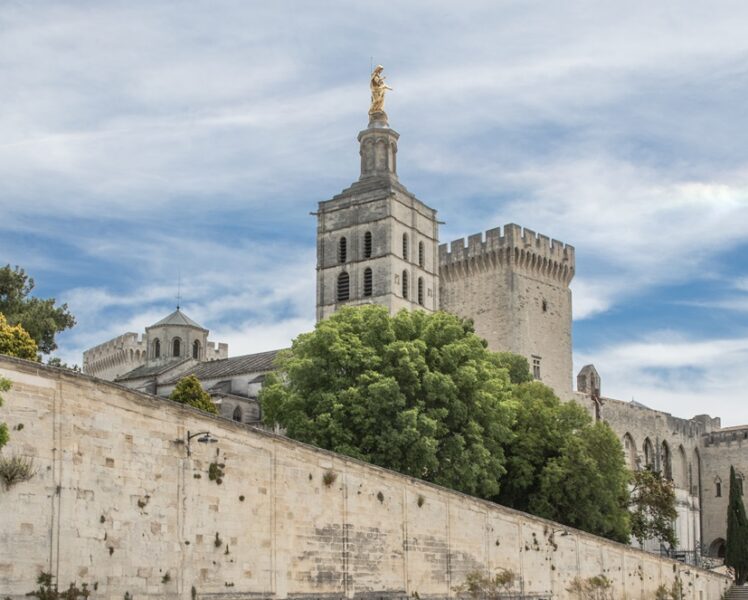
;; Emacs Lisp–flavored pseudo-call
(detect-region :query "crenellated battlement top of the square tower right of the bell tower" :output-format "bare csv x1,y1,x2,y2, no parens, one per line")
439,223,575,285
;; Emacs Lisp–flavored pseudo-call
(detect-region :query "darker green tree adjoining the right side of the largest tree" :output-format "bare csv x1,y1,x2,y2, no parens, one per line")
496,382,630,543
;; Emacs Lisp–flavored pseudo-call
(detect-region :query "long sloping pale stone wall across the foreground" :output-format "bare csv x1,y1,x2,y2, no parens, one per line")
0,358,729,600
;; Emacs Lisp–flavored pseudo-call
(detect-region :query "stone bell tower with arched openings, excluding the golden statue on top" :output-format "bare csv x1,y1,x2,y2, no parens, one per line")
316,111,439,320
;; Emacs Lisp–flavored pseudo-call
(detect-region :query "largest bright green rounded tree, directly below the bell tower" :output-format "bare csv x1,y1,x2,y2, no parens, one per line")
260,306,514,497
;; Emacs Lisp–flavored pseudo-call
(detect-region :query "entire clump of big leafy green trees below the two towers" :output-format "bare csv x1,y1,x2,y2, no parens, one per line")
260,306,630,542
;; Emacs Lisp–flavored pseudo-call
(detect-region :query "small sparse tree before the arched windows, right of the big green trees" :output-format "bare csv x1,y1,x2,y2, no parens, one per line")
629,467,678,548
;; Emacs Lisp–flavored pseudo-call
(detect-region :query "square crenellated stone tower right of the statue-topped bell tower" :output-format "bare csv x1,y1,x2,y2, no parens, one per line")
439,224,574,399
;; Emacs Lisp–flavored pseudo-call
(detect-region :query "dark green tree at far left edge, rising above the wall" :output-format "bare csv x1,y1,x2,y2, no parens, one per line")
0,265,75,354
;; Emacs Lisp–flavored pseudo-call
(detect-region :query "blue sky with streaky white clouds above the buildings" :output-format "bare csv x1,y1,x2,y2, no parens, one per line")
0,0,748,426
